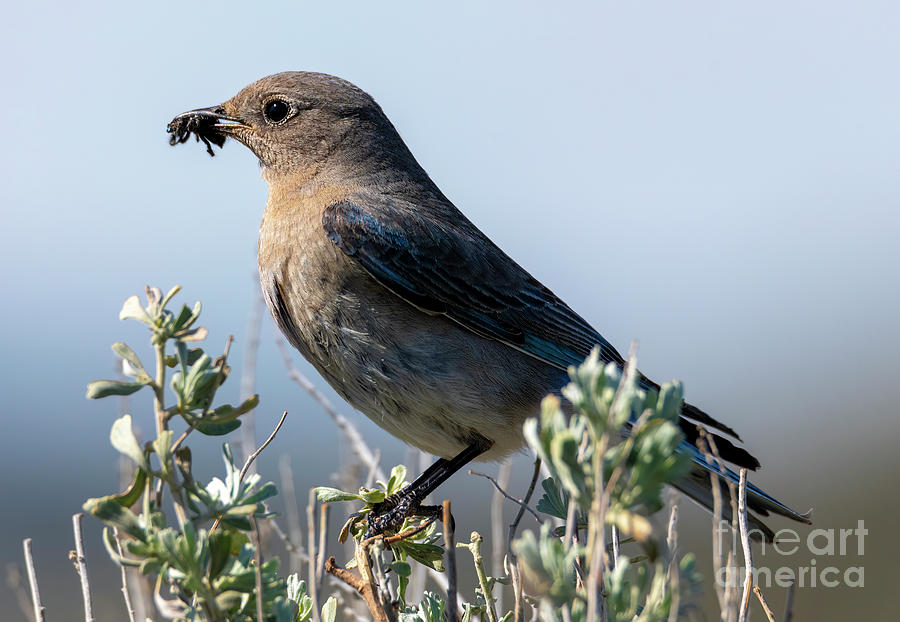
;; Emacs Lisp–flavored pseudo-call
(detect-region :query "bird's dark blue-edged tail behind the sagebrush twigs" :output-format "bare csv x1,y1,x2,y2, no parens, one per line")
673,437,812,542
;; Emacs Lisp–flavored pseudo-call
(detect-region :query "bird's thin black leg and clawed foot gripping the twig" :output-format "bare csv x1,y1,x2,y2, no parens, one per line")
366,439,493,538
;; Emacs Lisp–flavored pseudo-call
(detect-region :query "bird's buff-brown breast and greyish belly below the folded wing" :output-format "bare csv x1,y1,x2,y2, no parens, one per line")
259,193,562,458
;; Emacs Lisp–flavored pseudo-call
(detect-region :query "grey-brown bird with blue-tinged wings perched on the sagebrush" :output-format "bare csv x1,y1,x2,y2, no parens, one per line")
168,72,808,537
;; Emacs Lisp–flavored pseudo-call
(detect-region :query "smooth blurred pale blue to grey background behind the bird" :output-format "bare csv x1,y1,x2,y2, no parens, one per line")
0,0,900,620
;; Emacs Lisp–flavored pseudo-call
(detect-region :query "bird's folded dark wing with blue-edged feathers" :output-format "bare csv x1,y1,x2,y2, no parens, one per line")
322,201,623,370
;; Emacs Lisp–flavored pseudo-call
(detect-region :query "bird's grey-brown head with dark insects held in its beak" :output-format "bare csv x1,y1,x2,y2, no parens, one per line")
167,71,405,180
